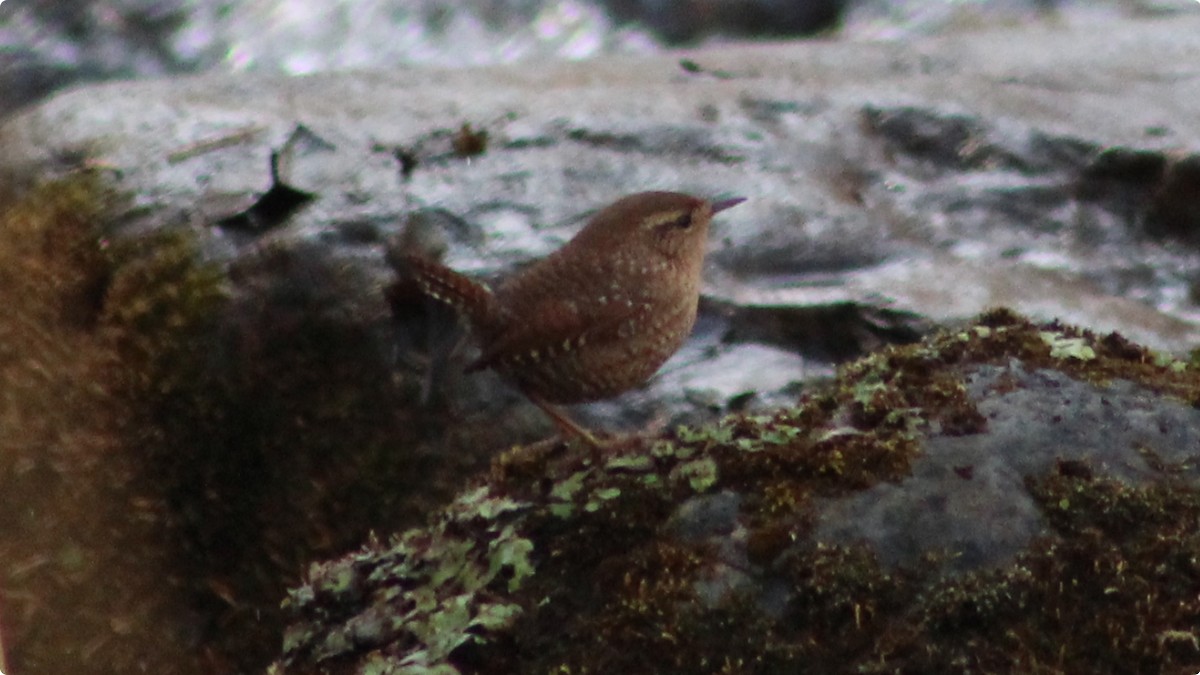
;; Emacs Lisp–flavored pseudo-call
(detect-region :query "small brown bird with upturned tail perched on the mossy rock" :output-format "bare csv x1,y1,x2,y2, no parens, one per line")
404,192,745,446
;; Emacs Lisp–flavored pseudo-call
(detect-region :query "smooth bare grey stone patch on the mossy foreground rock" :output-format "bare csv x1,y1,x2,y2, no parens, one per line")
815,363,1200,571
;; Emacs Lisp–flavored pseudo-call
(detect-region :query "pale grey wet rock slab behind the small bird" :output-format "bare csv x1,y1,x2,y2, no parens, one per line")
2,18,1200,439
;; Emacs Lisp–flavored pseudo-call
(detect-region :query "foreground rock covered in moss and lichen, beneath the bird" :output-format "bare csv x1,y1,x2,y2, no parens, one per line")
270,311,1200,674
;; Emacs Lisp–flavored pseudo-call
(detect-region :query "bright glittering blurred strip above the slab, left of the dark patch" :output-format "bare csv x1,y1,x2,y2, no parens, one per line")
0,0,667,118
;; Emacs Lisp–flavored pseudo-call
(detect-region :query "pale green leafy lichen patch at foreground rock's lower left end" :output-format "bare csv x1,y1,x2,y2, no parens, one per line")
276,488,534,673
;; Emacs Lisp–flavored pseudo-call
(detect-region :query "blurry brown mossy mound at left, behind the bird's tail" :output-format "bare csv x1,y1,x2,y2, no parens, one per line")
0,169,511,675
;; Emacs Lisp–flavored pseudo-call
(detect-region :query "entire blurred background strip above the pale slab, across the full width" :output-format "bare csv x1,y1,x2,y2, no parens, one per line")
0,0,1200,117
